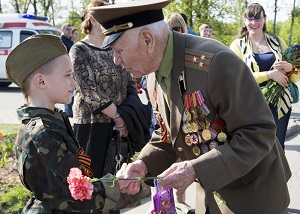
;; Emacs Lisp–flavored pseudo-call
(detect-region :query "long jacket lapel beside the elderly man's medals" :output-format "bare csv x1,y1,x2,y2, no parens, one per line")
170,32,185,142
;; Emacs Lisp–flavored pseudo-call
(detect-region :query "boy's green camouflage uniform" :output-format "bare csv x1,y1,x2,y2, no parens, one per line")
15,107,120,213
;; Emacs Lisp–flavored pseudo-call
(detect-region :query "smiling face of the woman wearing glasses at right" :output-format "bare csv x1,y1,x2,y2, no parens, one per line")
244,12,266,35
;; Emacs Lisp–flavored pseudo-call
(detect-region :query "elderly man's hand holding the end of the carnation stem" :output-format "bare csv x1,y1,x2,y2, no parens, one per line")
158,161,197,191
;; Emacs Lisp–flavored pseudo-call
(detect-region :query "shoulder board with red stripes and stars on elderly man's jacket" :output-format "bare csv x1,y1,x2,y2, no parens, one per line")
184,48,214,72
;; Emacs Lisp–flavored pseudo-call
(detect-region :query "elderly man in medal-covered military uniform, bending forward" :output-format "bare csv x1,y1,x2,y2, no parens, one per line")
92,0,291,214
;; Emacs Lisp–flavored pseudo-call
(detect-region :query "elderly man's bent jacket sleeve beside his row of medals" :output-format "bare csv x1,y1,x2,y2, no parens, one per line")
191,52,276,191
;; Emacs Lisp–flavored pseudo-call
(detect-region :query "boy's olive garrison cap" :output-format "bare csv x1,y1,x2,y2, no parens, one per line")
5,34,68,86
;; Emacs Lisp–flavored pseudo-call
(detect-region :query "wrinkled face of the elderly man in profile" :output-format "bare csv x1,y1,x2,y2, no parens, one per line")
111,30,158,78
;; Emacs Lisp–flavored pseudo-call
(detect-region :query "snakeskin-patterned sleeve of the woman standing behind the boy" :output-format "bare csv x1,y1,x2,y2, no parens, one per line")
70,45,111,112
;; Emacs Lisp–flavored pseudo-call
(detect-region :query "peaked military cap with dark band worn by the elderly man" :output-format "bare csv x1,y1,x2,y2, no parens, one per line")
90,0,171,48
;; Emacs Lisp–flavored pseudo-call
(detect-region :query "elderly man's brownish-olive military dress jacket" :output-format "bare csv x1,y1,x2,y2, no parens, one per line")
139,32,291,214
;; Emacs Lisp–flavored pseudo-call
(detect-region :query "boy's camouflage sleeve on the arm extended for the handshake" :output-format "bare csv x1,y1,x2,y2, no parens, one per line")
23,128,119,211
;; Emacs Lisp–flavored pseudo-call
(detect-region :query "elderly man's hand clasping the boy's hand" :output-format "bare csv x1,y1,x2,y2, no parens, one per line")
117,160,148,195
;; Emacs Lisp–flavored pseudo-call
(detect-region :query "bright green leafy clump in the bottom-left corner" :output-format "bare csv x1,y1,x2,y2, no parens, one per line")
0,184,31,214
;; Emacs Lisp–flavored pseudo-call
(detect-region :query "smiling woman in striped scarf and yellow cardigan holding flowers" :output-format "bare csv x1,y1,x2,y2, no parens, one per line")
230,3,299,149
